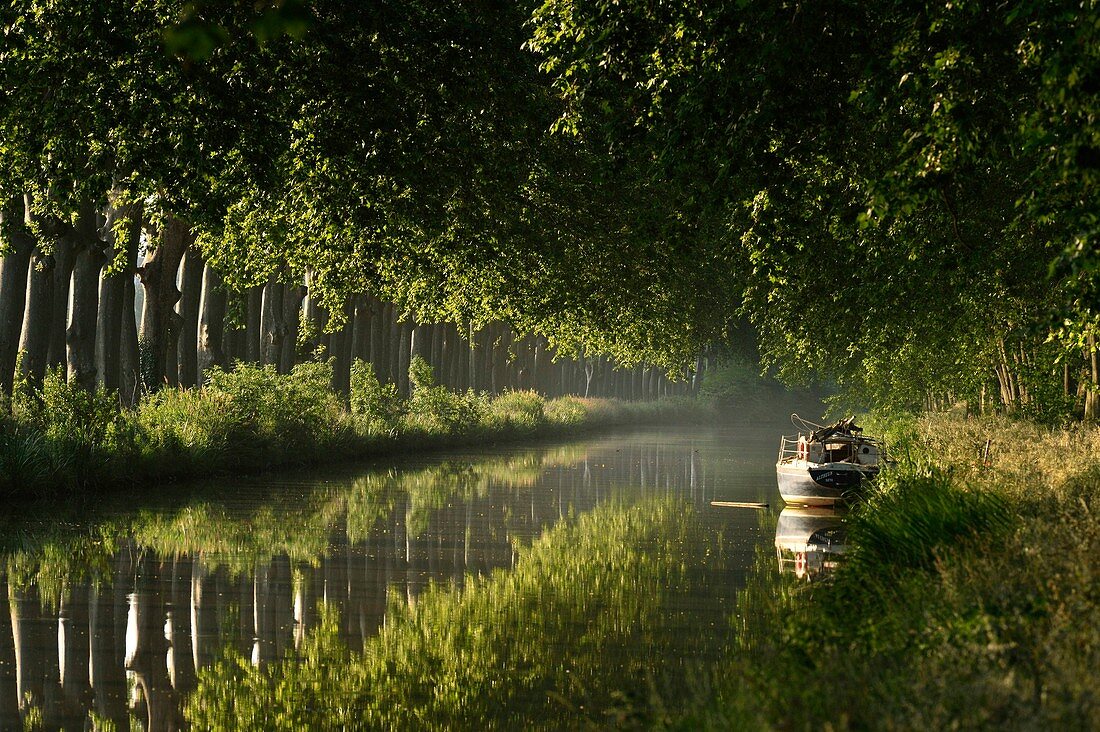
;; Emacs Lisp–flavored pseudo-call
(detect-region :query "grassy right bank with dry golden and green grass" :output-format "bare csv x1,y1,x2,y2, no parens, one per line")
681,415,1100,730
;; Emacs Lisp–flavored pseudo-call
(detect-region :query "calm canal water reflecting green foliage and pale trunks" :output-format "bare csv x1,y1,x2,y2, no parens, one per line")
0,423,783,730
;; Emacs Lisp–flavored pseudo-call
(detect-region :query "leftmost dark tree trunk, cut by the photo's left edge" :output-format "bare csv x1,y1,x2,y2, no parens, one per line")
0,197,34,396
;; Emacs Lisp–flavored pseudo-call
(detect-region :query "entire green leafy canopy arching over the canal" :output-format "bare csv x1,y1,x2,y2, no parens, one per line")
0,0,1100,401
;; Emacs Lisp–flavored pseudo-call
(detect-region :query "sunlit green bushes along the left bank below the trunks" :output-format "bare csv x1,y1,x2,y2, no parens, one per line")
0,358,705,495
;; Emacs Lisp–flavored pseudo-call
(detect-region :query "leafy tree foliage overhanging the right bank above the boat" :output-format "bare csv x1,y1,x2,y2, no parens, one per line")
529,0,1098,414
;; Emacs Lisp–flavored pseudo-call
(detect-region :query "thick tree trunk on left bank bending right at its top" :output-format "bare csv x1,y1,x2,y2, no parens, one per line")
138,216,195,391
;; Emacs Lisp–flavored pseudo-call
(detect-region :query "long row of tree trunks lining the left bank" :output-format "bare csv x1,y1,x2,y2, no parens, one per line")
0,198,700,405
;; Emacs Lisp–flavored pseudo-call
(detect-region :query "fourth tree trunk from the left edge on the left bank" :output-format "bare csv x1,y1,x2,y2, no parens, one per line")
65,205,107,392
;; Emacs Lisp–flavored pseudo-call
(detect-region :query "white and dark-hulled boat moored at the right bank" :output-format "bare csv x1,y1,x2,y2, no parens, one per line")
776,414,886,506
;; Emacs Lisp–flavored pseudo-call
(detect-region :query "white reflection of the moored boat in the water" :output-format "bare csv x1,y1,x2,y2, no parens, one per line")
776,506,847,580
